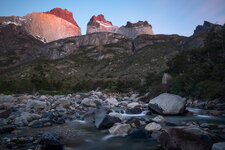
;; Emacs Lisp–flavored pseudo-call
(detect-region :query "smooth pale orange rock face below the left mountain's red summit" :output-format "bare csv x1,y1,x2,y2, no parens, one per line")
23,13,80,42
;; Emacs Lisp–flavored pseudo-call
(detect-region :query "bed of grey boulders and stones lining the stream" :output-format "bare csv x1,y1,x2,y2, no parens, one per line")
0,91,225,150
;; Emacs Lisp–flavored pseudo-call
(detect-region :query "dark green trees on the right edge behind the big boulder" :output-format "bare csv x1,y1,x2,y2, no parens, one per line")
167,26,225,99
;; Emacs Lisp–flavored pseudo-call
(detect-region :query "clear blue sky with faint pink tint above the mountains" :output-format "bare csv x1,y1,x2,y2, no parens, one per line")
0,0,225,36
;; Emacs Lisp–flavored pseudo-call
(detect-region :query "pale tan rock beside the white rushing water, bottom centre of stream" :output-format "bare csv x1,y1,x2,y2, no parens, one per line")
109,123,131,135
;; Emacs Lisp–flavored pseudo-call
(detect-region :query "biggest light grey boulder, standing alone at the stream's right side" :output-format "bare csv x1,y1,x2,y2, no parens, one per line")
149,93,185,115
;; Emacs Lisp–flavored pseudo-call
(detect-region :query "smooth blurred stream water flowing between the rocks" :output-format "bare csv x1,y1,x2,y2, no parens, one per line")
2,108,225,150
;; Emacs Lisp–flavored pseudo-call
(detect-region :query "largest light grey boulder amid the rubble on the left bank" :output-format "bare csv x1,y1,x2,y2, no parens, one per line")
26,99,46,111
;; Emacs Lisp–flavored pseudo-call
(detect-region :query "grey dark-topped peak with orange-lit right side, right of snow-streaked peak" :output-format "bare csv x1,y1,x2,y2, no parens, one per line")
117,21,154,38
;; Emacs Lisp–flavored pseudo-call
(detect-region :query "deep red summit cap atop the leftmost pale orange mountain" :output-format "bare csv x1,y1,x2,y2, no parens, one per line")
45,8,78,27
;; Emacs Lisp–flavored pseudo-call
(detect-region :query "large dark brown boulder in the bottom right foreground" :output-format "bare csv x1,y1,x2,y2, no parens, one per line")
159,126,219,150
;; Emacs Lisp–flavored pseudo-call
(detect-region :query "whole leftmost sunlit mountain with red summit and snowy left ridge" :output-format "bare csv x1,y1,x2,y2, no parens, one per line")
0,8,81,42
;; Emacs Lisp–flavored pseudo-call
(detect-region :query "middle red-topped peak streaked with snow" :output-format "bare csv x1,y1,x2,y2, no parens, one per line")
87,14,118,34
